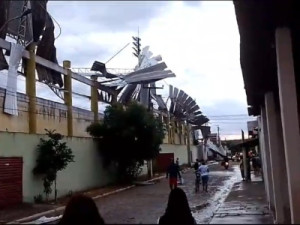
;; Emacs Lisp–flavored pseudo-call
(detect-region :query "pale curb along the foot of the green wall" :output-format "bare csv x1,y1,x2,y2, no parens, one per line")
6,176,165,224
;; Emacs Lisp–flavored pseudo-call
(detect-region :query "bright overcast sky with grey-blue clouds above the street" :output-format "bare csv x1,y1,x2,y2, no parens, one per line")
1,1,253,139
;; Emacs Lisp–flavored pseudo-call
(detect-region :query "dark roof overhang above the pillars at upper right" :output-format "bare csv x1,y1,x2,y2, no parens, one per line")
233,0,300,116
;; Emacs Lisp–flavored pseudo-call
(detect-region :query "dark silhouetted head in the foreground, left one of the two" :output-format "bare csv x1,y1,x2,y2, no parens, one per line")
58,195,104,225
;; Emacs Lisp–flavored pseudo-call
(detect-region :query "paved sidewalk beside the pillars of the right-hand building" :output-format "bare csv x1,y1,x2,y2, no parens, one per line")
210,173,273,224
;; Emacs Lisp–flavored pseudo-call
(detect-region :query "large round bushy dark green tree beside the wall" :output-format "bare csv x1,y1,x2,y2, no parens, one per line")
87,103,165,181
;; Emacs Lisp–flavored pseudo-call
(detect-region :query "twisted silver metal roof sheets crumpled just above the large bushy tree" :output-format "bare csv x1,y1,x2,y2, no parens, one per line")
86,46,175,105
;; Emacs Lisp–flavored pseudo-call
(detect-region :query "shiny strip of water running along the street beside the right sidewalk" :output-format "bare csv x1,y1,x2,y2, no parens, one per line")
192,166,240,224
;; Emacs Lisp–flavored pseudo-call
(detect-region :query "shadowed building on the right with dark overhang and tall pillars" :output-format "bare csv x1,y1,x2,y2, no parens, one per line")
233,0,300,224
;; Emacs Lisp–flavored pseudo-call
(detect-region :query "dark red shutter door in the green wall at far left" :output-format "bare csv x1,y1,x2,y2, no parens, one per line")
0,157,23,208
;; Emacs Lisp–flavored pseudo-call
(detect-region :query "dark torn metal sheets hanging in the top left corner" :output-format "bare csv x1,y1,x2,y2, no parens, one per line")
0,0,63,87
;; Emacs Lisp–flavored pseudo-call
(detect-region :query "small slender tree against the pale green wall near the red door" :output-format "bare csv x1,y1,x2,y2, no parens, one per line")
33,129,74,201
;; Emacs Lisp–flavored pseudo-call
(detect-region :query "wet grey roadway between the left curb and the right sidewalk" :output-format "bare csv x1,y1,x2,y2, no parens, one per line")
96,164,240,224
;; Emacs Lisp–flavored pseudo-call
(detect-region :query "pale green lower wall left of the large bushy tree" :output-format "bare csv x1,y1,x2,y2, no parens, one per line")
0,132,115,202
